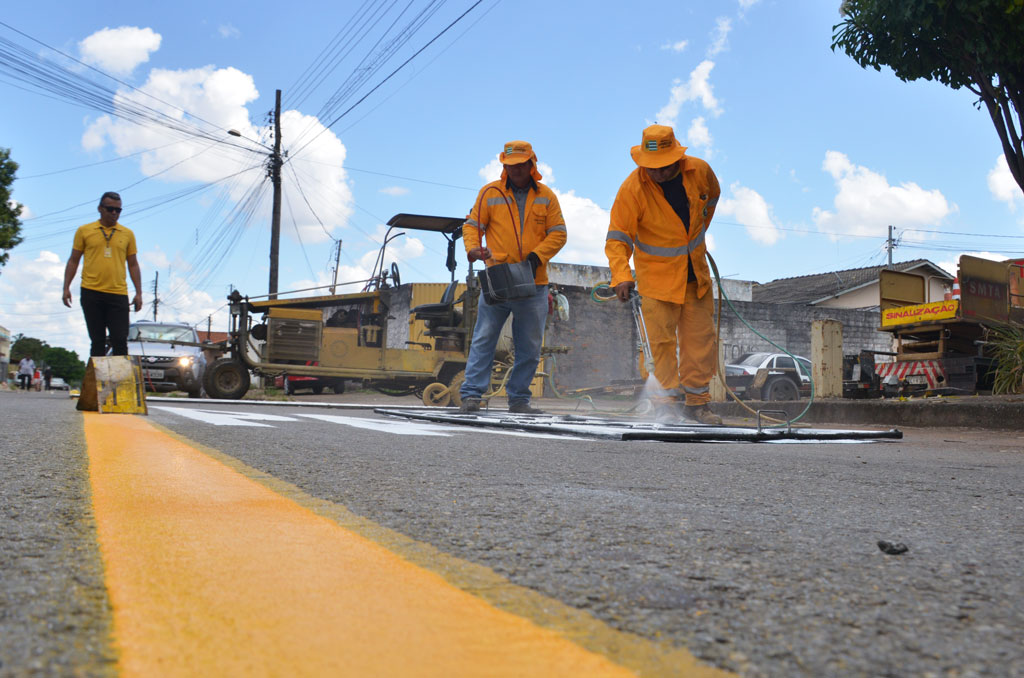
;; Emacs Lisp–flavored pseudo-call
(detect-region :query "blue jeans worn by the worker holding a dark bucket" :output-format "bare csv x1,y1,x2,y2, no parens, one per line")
459,285,548,405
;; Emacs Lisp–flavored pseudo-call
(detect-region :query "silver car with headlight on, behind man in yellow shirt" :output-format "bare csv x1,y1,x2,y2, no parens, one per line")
128,321,206,397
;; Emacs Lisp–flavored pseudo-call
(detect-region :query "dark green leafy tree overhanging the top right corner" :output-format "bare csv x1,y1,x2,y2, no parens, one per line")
831,0,1024,196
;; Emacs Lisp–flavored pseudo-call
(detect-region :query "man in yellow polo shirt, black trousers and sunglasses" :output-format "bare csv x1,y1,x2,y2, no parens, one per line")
63,192,142,355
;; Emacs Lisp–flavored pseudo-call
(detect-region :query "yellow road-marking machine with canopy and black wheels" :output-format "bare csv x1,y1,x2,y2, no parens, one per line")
204,214,479,405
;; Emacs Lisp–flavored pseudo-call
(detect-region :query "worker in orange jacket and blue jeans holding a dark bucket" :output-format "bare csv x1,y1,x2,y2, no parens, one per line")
459,141,566,414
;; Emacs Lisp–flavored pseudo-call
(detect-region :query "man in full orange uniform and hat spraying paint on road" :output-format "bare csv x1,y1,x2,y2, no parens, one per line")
604,125,722,425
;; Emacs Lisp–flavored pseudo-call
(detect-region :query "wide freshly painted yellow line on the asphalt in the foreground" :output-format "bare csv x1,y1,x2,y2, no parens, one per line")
85,414,726,676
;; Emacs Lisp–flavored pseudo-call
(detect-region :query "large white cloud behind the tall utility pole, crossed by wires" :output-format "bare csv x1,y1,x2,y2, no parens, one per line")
82,66,352,245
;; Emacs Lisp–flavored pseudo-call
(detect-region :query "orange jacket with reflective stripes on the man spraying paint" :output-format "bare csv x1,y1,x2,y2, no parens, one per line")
604,156,722,304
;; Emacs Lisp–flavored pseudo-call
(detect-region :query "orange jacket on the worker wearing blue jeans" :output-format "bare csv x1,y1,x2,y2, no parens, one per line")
462,179,567,285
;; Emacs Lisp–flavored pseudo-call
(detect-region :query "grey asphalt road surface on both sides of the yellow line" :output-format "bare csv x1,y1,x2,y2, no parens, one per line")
0,393,1024,676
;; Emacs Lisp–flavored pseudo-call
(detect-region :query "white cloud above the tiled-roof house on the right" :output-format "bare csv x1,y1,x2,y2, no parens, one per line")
812,151,956,239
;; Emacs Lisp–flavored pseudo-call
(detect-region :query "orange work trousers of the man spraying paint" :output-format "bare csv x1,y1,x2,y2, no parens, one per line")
642,283,718,405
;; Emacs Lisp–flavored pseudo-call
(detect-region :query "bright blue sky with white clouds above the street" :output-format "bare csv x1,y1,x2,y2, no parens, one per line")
0,0,1024,355
